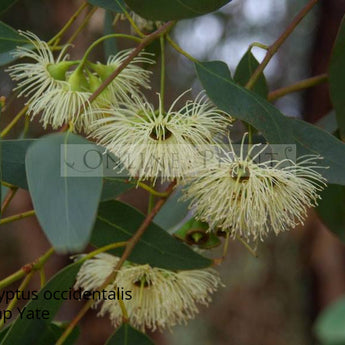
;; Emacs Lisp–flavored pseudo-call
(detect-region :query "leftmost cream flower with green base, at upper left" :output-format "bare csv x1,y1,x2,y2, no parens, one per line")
7,31,73,102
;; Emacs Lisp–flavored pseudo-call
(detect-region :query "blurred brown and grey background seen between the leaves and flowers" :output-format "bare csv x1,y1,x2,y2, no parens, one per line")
0,0,345,345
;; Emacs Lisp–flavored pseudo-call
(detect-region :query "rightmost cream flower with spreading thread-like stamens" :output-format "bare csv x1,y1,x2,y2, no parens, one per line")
185,136,325,240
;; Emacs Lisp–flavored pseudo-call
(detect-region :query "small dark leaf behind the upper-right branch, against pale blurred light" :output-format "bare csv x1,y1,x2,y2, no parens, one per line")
234,50,268,98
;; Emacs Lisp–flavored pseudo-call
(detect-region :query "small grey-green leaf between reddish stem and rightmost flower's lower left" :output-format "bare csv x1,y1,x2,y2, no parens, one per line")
155,189,189,230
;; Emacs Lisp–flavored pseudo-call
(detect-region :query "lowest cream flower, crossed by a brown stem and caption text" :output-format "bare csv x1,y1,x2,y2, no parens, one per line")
75,254,221,330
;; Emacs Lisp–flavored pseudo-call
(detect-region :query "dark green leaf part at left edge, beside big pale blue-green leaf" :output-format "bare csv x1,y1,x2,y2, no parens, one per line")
2,139,36,189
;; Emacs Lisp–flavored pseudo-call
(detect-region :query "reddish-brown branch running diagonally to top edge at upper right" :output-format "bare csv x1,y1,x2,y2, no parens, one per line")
246,0,318,89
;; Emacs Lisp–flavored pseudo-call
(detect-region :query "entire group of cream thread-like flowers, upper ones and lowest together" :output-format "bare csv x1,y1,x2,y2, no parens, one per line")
8,32,325,329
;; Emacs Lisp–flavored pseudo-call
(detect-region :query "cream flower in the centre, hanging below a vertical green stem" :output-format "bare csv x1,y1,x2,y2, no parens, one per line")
92,94,231,182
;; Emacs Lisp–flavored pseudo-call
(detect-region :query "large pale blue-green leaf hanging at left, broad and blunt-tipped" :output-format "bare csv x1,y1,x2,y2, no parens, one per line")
25,133,102,252
